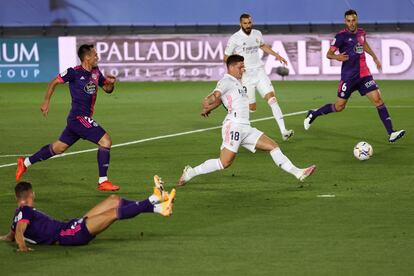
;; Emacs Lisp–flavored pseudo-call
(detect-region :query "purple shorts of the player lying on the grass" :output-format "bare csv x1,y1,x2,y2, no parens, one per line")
58,218,95,245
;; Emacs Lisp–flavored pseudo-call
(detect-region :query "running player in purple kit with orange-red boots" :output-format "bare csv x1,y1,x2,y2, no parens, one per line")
16,44,119,191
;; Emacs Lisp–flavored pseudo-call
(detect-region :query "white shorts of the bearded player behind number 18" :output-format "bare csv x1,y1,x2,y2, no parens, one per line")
242,67,275,104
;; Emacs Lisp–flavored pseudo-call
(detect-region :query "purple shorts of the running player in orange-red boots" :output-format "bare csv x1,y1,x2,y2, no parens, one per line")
59,116,106,146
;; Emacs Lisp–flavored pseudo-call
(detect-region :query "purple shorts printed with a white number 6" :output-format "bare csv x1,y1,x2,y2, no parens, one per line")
338,76,379,99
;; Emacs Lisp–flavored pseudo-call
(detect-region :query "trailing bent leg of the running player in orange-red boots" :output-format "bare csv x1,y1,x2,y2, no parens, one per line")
16,141,69,182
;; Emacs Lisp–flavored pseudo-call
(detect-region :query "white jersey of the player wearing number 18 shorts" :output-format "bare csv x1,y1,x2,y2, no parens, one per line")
214,74,250,125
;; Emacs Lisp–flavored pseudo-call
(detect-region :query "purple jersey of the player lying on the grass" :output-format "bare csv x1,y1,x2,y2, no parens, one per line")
11,206,65,244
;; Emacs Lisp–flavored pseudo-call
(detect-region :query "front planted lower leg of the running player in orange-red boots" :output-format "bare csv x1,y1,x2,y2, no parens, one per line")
97,133,119,191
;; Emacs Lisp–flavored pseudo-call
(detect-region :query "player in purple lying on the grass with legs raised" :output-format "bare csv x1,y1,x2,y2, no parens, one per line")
0,176,175,251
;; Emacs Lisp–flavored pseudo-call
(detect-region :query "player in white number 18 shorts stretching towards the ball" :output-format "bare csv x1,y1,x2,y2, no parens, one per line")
178,55,316,186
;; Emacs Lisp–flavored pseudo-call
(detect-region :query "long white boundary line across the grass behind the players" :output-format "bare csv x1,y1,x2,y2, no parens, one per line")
0,110,308,168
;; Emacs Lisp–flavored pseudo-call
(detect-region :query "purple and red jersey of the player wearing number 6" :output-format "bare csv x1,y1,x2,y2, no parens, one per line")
331,28,371,81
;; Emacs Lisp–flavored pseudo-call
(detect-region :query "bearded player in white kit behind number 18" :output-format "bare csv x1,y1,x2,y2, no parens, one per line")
224,13,294,141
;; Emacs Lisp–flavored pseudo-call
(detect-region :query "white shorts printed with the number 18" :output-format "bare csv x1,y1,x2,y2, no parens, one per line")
220,121,263,153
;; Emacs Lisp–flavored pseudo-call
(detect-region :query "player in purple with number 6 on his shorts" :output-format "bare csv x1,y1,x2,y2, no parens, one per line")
303,10,405,143
